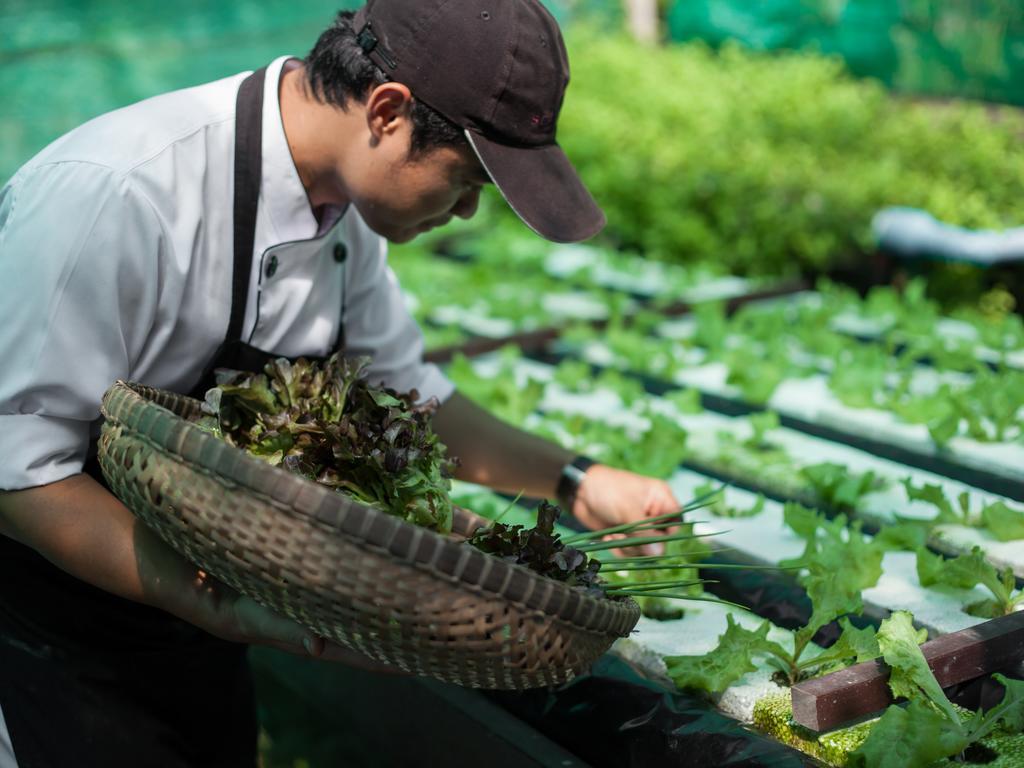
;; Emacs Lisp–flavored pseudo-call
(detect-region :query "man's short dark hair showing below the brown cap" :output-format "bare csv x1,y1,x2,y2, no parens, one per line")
305,10,469,157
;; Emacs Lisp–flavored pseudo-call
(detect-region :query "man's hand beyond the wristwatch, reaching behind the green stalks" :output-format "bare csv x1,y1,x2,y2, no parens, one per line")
571,464,681,555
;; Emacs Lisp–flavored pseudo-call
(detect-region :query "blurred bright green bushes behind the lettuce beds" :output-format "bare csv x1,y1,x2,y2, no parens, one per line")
559,36,1024,273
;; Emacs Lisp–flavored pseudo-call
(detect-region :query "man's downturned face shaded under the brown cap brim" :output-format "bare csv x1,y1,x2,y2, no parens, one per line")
353,143,489,243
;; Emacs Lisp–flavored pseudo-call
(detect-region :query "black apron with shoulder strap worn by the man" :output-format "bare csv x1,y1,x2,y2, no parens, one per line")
0,68,344,768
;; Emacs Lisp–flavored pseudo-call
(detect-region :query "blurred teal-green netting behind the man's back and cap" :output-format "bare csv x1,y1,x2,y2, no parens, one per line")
0,0,620,184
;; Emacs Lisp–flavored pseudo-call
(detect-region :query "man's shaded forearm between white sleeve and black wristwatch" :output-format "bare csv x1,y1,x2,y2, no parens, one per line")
434,392,572,499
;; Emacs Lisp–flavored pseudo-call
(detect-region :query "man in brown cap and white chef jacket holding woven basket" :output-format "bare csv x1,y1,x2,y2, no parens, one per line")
0,0,677,766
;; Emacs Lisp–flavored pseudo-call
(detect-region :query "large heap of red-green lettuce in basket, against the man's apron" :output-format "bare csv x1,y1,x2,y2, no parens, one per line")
201,354,455,534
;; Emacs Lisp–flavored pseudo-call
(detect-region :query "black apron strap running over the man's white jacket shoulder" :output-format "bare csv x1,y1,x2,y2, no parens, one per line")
226,67,266,341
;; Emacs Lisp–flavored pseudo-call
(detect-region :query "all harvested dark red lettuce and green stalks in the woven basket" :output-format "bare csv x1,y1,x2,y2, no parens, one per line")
199,354,720,599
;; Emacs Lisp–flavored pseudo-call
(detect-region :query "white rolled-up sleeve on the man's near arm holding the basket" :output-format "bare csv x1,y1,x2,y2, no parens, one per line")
0,162,162,490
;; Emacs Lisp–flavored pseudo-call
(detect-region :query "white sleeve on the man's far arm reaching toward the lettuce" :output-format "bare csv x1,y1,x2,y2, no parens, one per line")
345,220,455,402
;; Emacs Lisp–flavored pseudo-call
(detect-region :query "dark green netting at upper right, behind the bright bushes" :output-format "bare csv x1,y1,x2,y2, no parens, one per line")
668,0,1024,104
